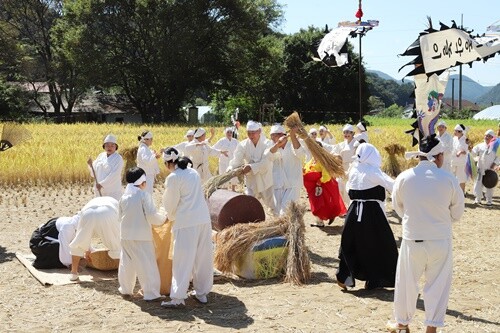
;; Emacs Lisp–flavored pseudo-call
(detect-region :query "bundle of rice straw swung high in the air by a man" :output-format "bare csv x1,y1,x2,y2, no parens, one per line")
283,112,345,178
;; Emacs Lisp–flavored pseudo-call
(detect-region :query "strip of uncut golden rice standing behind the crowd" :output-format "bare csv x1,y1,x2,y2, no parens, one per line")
0,117,498,184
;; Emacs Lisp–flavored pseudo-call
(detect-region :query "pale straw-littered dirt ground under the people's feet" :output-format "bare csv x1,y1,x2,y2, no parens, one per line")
0,185,500,333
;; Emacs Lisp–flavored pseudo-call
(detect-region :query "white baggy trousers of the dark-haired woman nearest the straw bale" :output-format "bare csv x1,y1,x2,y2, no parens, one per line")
170,223,214,300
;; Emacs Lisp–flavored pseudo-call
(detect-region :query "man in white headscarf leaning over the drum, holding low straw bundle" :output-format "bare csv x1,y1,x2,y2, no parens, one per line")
227,120,275,214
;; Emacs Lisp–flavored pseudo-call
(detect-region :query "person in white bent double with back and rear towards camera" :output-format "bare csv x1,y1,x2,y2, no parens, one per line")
69,197,121,281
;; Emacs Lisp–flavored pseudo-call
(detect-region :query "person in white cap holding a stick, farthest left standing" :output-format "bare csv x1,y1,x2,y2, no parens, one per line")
87,134,123,200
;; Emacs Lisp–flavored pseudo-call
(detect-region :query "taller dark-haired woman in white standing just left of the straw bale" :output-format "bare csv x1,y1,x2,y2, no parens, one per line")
161,148,214,308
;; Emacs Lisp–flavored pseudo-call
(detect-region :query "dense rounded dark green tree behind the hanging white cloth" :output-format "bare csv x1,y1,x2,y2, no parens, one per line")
279,27,368,123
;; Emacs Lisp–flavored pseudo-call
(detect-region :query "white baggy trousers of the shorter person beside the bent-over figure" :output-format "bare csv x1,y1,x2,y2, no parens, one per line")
118,239,161,301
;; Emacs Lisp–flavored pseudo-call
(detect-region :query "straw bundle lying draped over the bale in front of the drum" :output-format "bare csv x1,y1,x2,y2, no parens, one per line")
214,218,288,274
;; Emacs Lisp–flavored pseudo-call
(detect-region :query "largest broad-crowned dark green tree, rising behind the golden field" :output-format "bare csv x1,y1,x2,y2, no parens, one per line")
60,0,282,122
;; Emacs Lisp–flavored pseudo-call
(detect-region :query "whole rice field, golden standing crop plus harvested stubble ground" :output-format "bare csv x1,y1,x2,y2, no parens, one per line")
0,118,500,333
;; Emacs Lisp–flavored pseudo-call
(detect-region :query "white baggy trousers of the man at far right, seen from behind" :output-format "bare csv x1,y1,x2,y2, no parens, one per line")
394,239,453,327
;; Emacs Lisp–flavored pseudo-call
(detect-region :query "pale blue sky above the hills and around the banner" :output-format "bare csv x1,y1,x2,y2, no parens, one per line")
278,0,500,86
